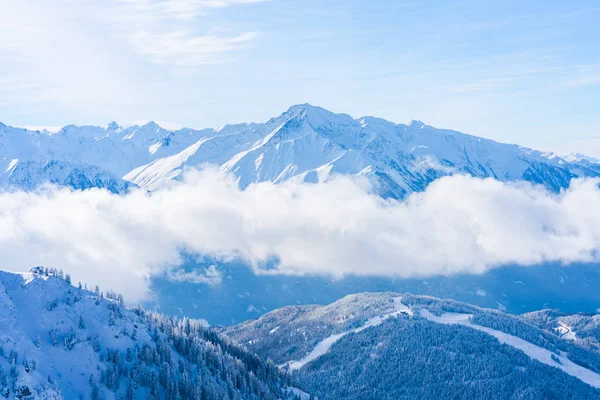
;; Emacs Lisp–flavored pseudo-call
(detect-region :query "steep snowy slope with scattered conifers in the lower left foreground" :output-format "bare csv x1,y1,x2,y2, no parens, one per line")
0,268,307,400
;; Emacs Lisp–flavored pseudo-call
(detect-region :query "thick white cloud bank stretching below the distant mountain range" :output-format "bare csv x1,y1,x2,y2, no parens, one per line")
0,171,600,301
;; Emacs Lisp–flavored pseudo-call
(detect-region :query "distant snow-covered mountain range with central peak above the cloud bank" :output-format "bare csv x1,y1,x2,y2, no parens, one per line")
0,104,600,197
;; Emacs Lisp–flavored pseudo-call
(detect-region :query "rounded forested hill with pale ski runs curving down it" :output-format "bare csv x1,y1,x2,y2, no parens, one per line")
223,293,600,399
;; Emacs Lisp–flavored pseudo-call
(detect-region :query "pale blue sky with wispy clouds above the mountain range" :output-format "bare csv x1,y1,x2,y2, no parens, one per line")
0,0,600,150
